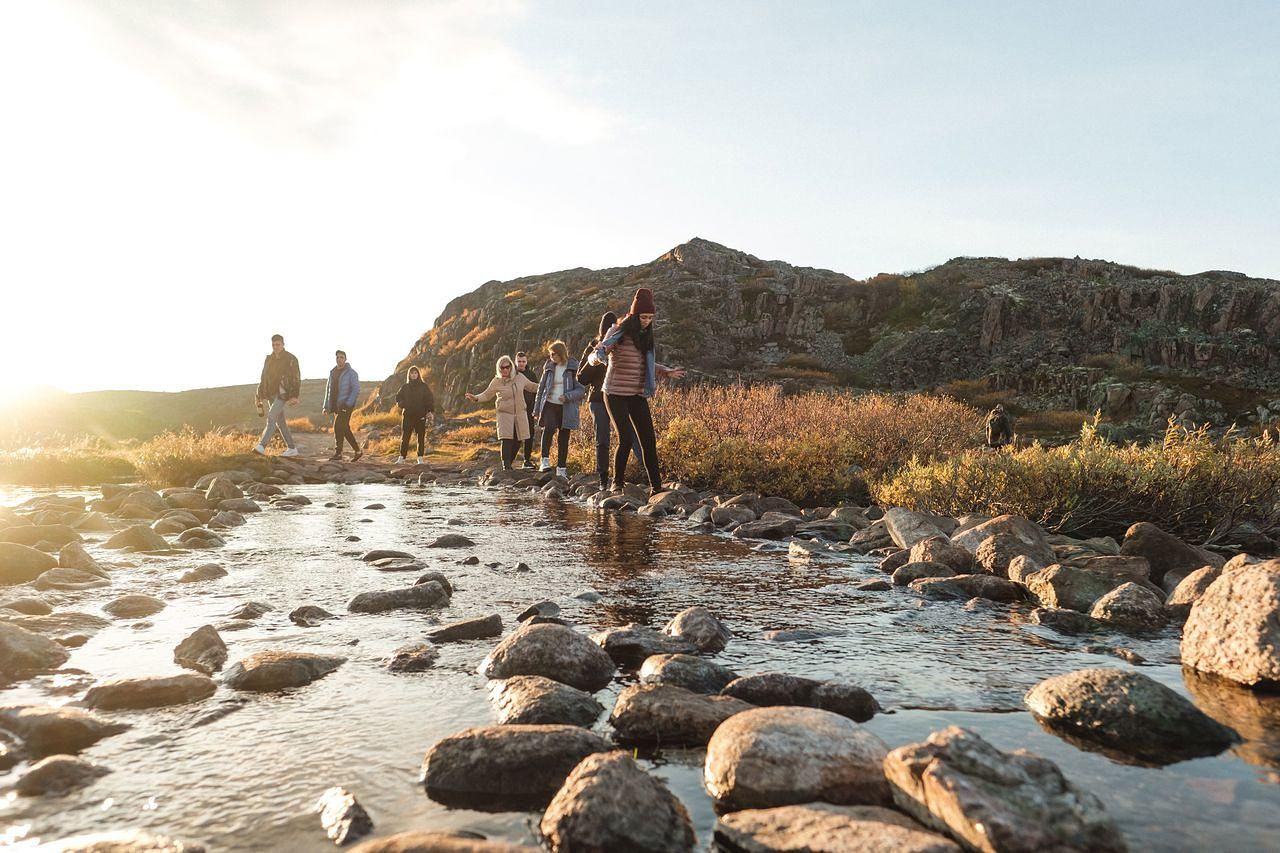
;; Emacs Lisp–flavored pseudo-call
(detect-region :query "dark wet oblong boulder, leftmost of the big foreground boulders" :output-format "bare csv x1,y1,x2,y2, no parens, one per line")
422,725,609,811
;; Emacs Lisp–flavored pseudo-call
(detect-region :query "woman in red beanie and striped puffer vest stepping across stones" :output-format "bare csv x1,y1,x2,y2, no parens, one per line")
590,287,685,494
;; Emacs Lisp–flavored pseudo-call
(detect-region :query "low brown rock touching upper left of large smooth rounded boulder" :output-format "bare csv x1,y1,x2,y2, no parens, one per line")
609,684,751,745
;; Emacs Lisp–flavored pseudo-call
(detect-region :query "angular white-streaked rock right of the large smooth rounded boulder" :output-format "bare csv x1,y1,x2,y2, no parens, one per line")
884,726,1126,853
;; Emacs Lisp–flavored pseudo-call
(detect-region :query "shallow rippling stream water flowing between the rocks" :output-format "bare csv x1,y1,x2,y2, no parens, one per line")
0,485,1280,850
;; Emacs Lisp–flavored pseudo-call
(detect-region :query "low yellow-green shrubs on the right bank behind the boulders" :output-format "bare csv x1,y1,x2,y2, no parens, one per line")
873,420,1280,542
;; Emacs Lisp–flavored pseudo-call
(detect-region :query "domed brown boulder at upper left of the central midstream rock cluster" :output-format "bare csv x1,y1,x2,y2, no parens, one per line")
480,624,617,692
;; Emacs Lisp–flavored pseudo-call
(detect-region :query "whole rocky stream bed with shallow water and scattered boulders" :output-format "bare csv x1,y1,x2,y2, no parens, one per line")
0,462,1280,850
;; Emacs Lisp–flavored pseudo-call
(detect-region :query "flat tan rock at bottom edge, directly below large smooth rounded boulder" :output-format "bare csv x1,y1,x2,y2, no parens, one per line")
716,803,960,853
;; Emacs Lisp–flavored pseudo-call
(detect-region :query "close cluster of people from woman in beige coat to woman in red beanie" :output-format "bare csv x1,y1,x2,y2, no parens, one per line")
466,287,685,491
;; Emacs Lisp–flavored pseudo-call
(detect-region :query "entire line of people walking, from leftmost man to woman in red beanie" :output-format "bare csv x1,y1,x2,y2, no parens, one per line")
253,287,685,491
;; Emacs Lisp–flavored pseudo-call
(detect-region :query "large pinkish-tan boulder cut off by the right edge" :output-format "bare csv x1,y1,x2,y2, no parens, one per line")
1181,560,1280,689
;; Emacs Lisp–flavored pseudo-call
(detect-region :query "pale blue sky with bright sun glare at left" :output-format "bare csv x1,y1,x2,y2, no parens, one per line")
0,0,1280,401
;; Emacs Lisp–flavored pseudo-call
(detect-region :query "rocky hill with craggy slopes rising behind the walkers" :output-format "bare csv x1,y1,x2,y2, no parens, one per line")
371,238,1280,435
